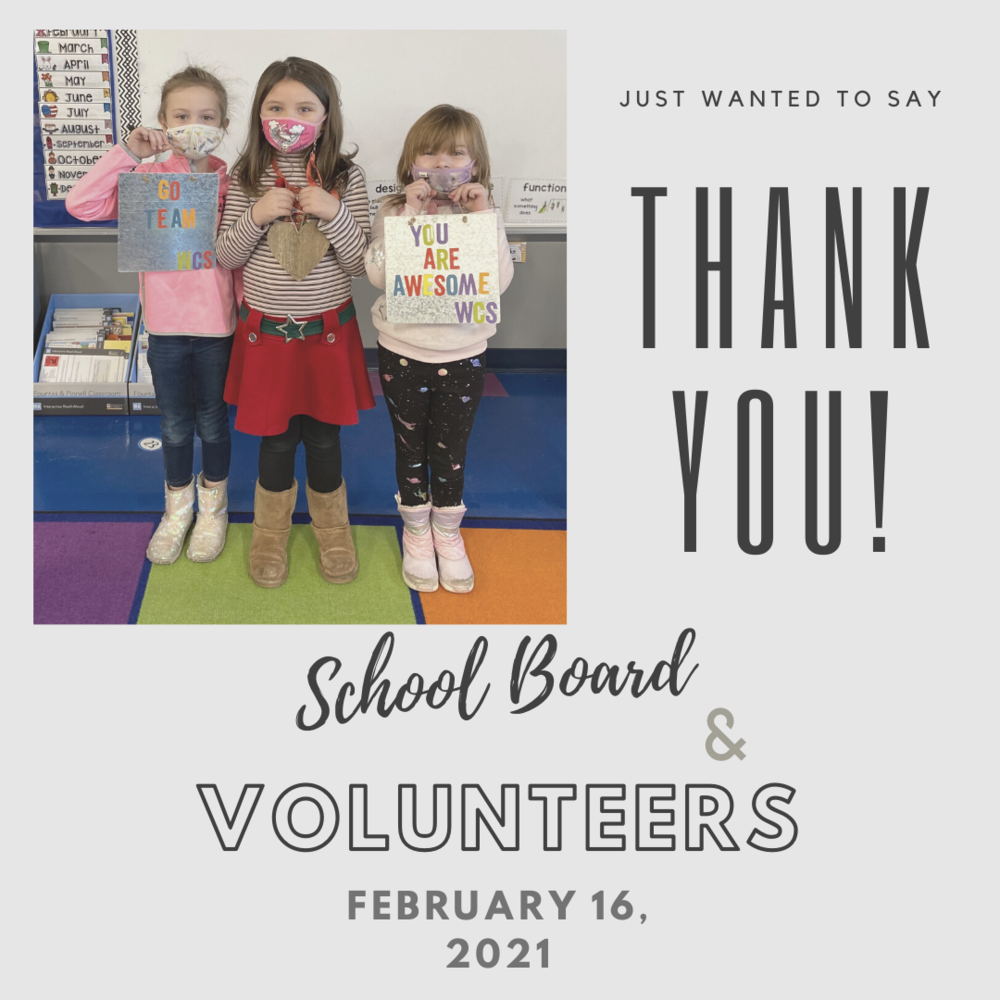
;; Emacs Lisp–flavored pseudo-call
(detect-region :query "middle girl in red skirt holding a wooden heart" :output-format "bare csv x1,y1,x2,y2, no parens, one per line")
216,58,375,587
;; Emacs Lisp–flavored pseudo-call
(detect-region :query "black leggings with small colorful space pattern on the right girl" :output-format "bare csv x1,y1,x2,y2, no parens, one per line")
378,344,486,507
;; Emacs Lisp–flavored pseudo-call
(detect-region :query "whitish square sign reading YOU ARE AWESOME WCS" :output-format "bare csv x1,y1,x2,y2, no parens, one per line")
385,212,500,323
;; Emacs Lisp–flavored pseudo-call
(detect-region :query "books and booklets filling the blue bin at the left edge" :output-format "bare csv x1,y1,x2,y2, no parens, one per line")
38,308,135,382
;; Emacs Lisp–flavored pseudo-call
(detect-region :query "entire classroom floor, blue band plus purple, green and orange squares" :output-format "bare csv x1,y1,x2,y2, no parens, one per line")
34,372,566,625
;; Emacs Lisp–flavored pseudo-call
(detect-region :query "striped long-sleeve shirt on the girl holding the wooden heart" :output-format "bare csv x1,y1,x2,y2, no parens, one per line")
215,154,371,316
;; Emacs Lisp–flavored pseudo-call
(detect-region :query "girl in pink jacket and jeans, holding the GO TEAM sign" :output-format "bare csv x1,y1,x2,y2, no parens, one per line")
66,66,236,564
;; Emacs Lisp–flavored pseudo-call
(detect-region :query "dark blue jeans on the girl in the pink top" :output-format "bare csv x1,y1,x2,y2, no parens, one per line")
147,333,233,486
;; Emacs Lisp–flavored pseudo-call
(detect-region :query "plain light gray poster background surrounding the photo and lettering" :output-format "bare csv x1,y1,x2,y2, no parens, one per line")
11,7,1000,1000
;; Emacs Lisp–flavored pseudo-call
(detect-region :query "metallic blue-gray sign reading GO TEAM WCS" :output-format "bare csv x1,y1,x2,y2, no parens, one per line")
118,173,219,271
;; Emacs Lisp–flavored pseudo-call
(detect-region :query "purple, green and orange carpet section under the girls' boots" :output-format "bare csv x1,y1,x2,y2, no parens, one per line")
35,514,566,625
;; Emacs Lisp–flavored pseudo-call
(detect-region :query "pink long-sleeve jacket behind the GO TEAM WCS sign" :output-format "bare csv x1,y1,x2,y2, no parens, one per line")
66,146,237,337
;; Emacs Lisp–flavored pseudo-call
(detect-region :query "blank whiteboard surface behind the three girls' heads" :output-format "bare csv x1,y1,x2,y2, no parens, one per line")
137,30,566,189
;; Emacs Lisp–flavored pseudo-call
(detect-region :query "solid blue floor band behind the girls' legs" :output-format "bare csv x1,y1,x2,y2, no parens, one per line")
34,372,566,519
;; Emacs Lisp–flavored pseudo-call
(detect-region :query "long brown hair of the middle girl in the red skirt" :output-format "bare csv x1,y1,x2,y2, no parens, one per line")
233,56,358,198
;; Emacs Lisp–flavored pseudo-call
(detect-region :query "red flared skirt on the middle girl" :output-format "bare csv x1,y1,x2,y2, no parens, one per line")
225,300,375,437
